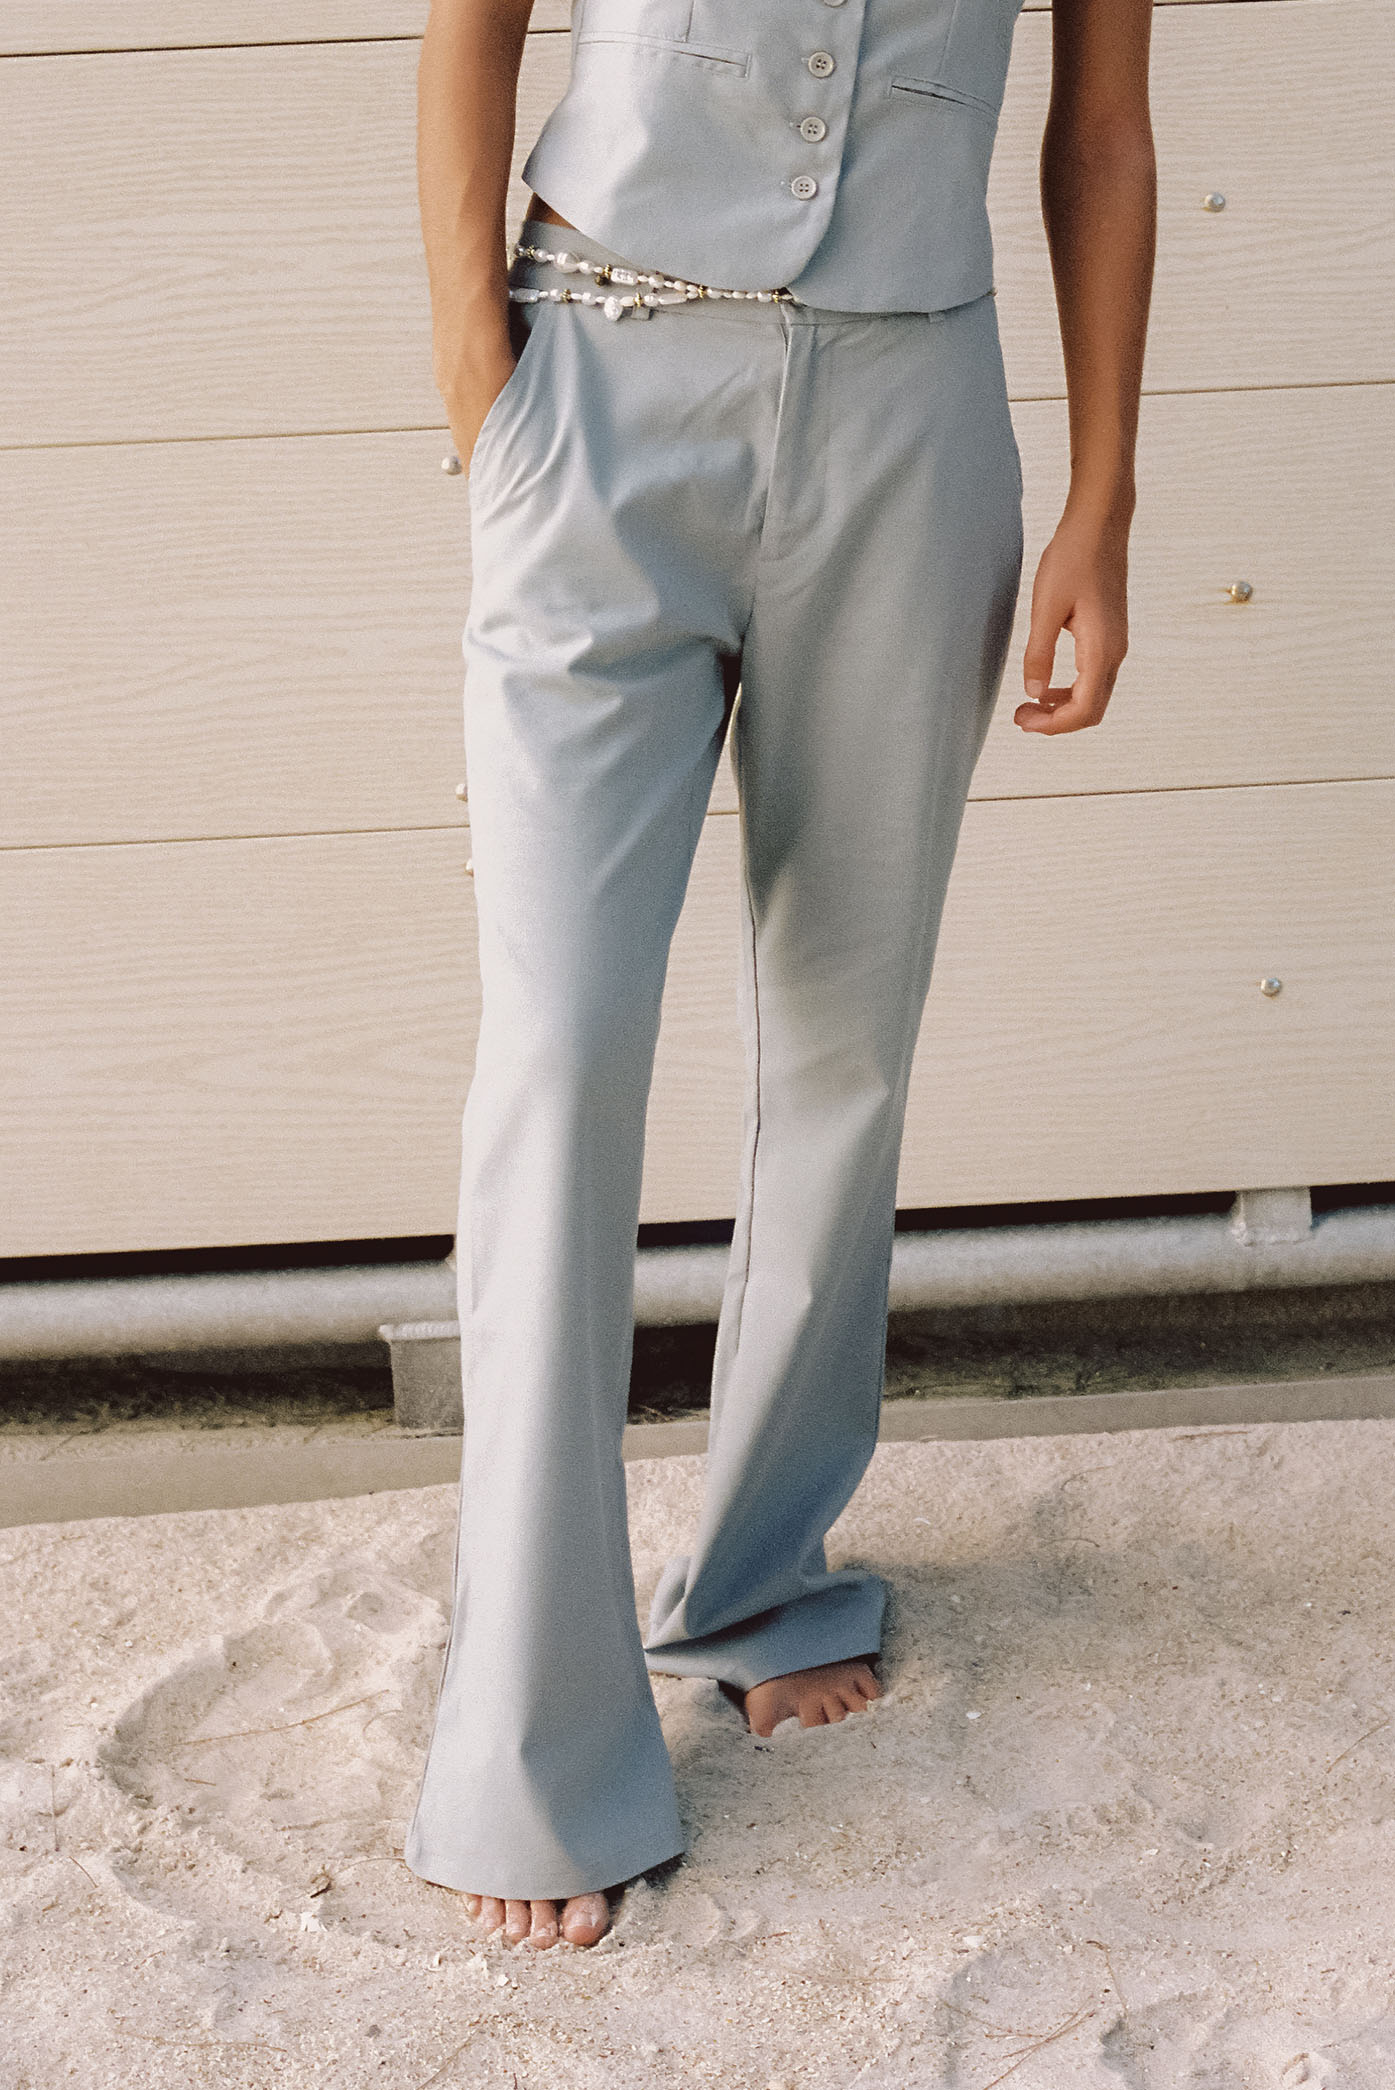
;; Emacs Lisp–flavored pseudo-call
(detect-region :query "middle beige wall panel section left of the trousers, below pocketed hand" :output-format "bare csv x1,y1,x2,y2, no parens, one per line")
0,431,471,844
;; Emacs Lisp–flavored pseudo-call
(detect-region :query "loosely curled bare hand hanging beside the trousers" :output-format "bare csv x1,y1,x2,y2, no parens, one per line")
1012,508,1129,734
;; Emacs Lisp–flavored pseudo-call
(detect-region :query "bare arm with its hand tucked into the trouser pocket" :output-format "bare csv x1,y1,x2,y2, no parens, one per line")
416,0,533,462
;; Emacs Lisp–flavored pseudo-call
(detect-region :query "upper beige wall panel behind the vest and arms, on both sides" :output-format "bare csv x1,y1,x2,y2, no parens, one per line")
10,0,1395,443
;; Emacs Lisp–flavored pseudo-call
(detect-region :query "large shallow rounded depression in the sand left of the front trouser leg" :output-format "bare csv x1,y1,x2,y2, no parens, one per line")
100,1563,445,1868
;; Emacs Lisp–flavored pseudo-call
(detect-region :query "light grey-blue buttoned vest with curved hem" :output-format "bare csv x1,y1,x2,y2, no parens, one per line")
523,0,1023,311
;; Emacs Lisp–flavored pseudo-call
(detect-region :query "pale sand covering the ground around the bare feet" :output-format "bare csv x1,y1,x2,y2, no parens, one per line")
0,1421,1395,2090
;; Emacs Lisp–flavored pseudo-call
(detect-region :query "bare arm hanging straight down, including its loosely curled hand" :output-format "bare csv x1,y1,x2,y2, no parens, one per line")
1014,0,1157,734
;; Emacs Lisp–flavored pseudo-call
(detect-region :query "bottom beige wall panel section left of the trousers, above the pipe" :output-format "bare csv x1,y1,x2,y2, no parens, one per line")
0,832,475,1256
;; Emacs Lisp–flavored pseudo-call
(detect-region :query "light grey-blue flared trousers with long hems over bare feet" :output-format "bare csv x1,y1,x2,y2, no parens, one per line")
406,224,1023,1898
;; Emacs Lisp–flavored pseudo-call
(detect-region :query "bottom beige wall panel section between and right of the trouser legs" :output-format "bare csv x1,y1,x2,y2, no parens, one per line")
646,782,1395,1221
